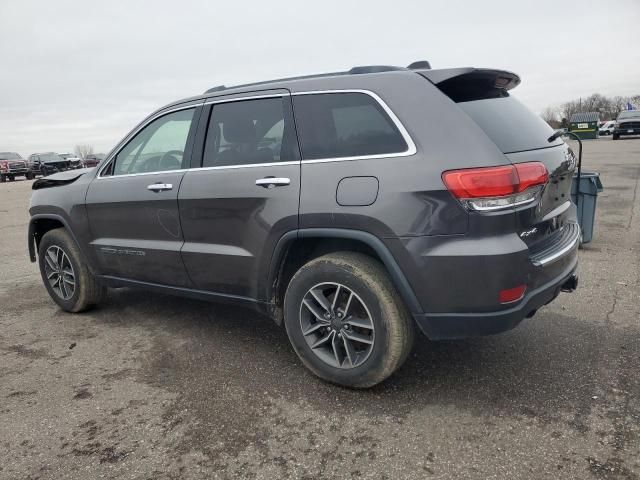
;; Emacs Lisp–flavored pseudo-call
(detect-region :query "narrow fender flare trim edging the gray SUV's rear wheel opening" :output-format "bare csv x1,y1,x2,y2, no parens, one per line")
266,228,423,314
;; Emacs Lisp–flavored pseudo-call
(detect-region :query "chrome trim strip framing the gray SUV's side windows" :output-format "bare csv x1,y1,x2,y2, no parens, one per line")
96,89,417,180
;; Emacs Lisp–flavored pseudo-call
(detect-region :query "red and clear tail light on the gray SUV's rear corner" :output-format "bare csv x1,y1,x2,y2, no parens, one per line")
442,162,549,211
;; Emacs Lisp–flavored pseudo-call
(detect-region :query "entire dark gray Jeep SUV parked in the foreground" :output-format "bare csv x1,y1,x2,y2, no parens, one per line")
28,62,580,387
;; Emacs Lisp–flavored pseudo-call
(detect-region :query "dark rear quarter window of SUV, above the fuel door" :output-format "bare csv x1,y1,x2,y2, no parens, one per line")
293,93,409,160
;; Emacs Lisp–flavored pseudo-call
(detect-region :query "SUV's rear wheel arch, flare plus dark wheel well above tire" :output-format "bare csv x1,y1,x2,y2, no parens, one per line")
265,228,422,324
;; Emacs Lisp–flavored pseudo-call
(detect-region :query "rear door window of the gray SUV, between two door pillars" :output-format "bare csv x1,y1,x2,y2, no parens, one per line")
202,97,299,167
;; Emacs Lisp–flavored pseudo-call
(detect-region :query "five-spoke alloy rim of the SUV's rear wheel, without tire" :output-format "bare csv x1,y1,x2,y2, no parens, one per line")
300,283,375,369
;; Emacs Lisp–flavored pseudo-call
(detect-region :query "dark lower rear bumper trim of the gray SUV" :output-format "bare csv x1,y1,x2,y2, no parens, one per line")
414,255,578,340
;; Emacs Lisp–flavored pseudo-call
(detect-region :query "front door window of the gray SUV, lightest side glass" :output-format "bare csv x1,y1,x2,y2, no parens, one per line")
109,108,195,175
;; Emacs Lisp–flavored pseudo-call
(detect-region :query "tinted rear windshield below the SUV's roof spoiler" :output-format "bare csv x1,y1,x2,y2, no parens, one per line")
457,94,562,153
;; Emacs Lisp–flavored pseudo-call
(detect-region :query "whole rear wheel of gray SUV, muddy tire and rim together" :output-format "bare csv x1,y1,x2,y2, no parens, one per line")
284,252,415,388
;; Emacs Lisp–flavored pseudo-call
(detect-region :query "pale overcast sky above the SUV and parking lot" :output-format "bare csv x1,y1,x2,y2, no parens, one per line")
0,0,640,156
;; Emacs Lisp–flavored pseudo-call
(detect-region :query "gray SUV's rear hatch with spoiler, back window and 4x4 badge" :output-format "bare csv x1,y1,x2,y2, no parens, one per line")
419,68,577,250
